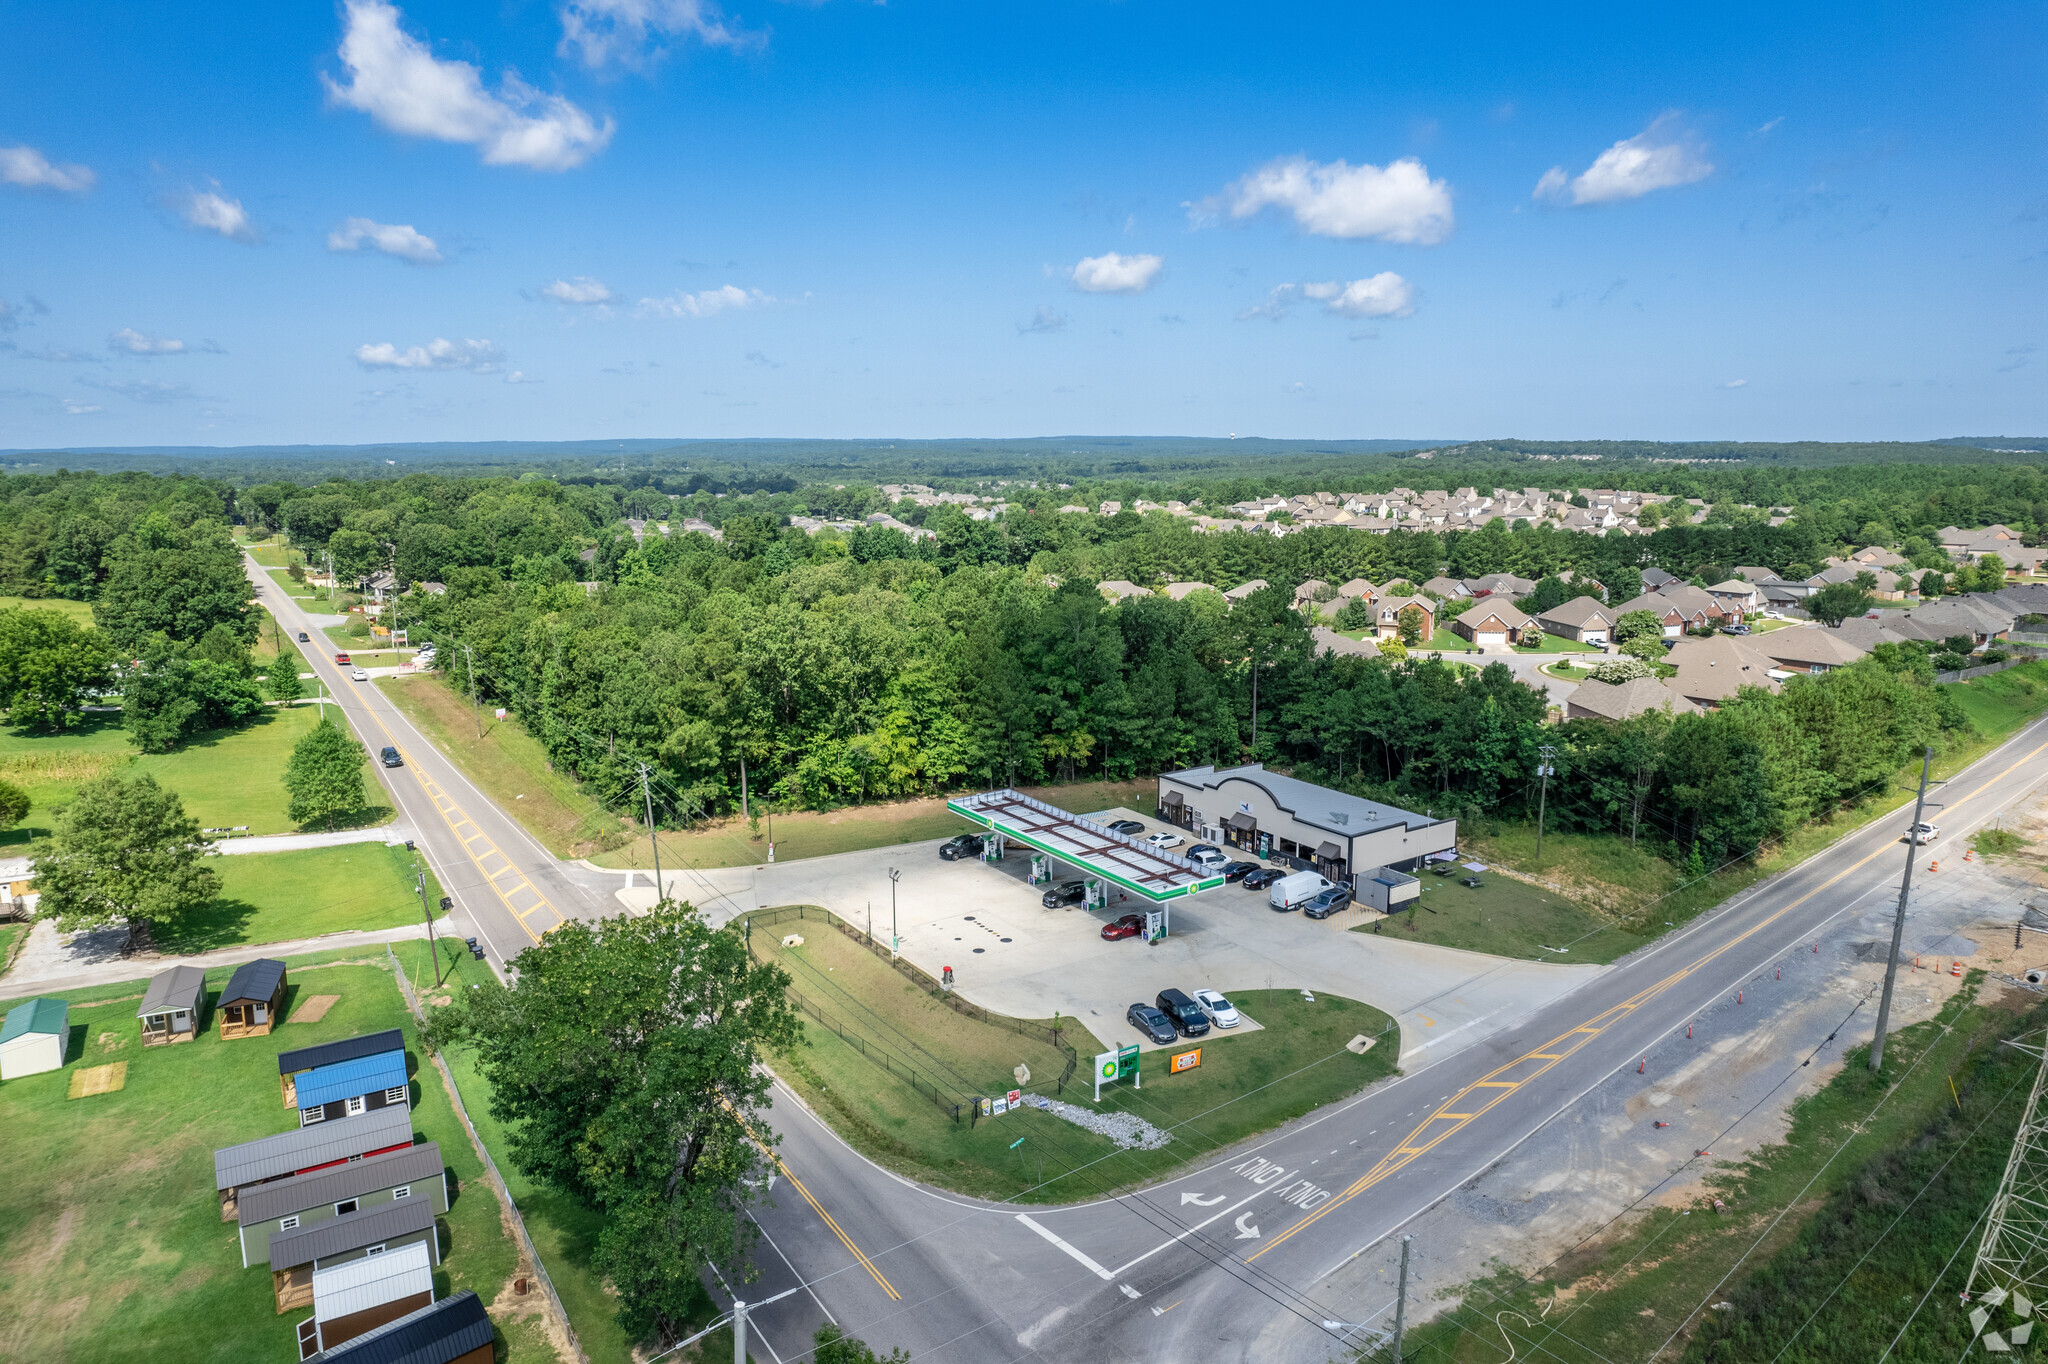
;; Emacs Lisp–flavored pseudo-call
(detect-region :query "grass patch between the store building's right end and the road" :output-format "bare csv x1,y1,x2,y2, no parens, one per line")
1352,864,1649,965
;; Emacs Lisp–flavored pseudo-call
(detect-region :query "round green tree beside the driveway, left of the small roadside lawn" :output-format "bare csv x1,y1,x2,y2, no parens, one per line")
33,772,221,952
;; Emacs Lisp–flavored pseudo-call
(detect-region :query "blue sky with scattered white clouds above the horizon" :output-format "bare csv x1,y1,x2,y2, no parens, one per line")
0,0,2048,446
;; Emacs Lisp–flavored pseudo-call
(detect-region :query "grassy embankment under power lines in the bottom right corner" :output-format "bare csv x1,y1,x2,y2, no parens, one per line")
1409,977,2048,1364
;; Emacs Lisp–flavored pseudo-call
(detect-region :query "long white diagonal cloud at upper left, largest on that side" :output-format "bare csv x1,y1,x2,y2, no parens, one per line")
322,0,612,170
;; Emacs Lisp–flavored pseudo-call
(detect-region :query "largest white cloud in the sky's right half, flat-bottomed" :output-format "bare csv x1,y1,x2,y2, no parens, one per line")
1190,156,1452,246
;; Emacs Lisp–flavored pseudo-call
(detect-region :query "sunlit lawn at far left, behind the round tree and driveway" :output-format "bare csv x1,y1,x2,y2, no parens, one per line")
0,705,393,848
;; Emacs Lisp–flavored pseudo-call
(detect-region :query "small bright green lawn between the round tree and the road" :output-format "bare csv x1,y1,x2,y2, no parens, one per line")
158,844,440,952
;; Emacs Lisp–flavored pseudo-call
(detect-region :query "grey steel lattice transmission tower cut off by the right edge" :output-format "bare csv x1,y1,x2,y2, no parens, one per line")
1962,1036,2048,1354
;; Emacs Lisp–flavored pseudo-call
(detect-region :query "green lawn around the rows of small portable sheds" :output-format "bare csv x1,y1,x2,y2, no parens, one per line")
0,954,557,1364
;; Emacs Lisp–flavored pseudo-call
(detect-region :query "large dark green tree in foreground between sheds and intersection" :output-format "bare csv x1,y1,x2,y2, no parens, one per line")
436,901,803,1339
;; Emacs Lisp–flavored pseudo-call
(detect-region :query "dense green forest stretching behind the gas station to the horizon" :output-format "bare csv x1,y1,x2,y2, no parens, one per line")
0,465,2048,862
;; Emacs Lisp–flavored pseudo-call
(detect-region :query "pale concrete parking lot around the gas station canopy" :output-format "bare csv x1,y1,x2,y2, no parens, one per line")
618,811,1604,1065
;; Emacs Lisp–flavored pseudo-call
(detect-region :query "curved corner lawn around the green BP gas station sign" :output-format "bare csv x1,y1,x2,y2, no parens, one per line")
754,924,1401,1202
